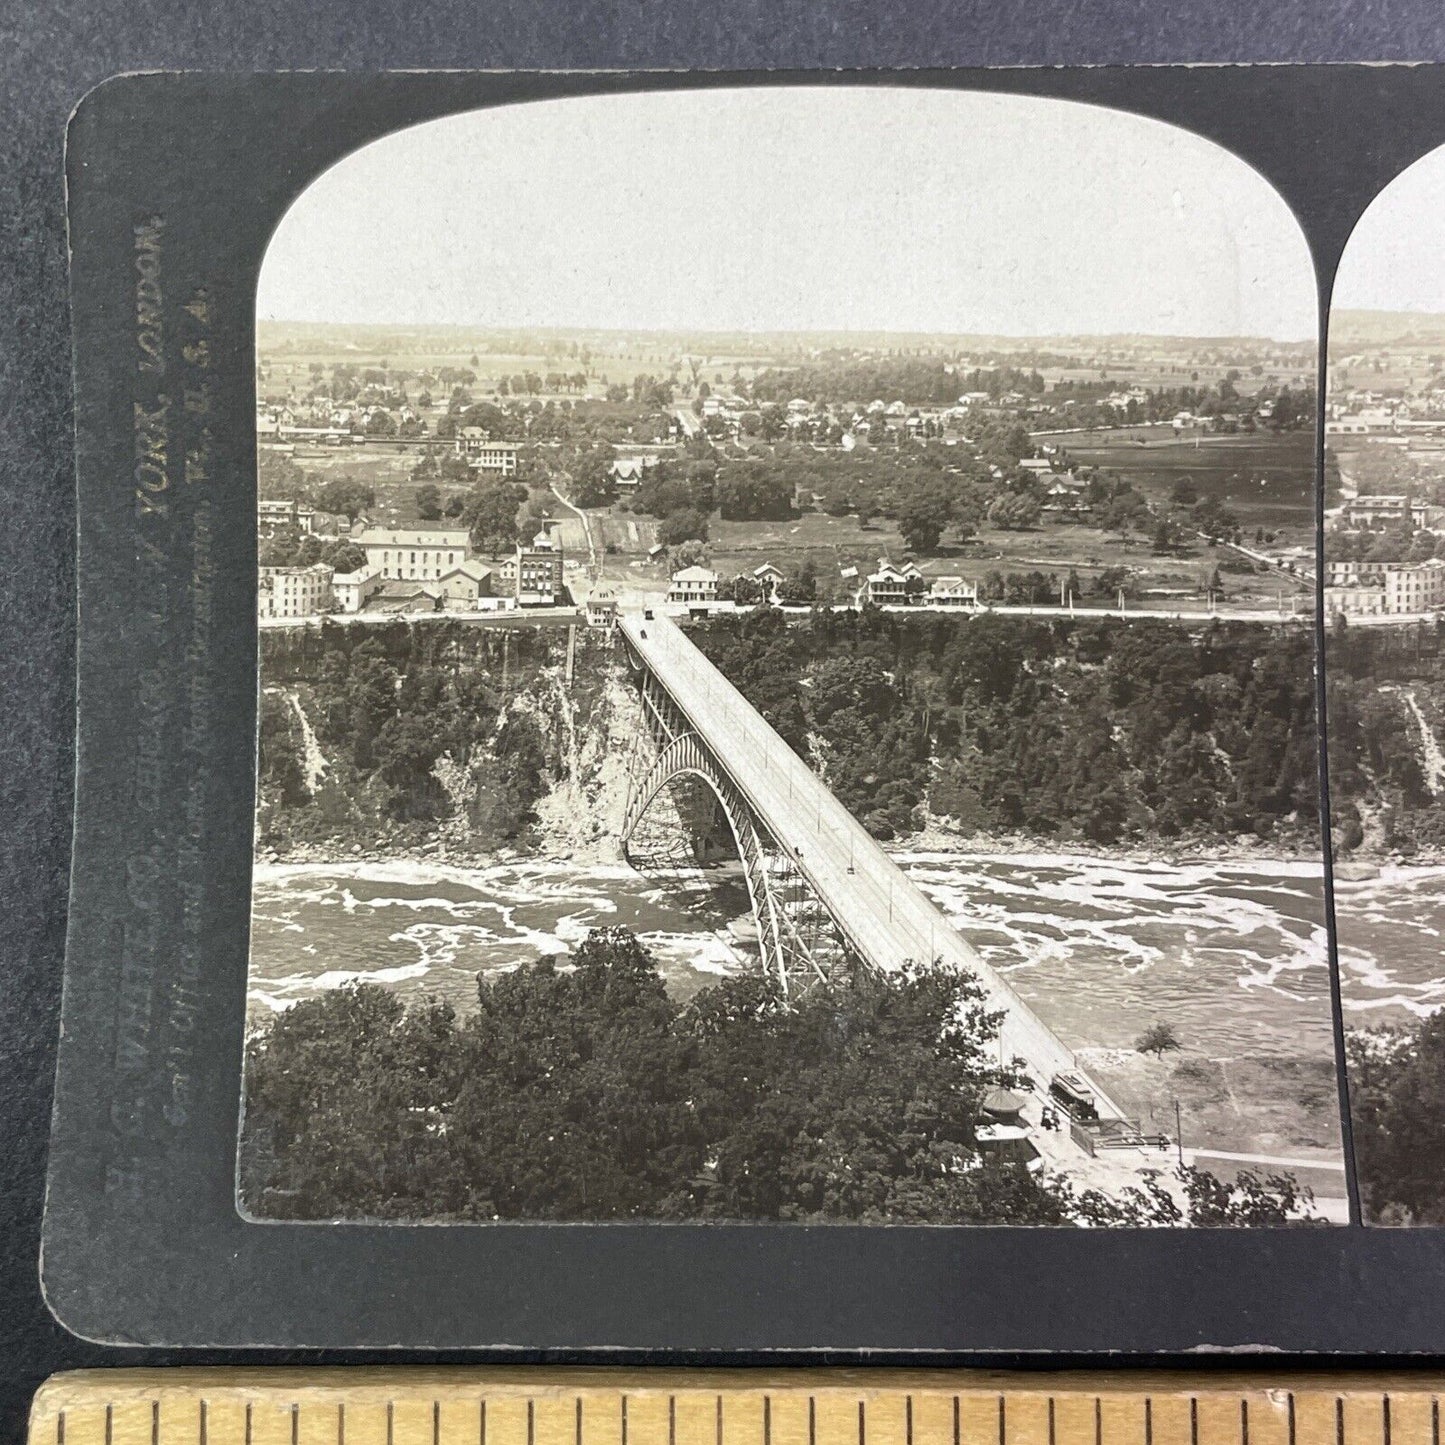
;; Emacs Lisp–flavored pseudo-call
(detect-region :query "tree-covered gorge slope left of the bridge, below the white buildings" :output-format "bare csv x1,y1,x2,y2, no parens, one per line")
256,621,605,853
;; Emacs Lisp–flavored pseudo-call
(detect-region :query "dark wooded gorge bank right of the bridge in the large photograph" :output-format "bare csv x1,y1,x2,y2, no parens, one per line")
691,608,1319,848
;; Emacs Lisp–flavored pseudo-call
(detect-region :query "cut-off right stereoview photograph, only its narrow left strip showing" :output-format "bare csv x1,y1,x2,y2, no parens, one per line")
1324,150,1445,1225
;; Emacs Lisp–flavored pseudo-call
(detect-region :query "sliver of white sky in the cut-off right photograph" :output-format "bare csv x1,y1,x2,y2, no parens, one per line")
1331,147,1445,312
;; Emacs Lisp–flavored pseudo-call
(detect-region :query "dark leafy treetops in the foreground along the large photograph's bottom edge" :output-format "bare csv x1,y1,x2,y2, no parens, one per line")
240,928,1312,1225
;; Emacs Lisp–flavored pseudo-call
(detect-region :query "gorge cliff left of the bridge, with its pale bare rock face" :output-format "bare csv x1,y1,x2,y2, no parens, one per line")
257,624,640,863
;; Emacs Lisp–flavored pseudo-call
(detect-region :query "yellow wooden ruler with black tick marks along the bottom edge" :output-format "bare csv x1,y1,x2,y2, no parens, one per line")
29,1367,1445,1445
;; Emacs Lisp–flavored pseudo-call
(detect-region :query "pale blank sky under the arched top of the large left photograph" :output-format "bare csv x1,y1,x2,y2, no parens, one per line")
257,87,1315,340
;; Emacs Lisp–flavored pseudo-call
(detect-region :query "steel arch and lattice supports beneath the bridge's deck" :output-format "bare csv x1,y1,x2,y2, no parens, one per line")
621,669,853,997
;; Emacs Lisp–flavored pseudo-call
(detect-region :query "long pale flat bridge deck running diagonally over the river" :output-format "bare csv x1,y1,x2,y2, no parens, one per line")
618,611,1118,1117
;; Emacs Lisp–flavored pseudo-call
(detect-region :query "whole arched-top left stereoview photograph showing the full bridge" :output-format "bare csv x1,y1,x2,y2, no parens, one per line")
237,87,1348,1227
